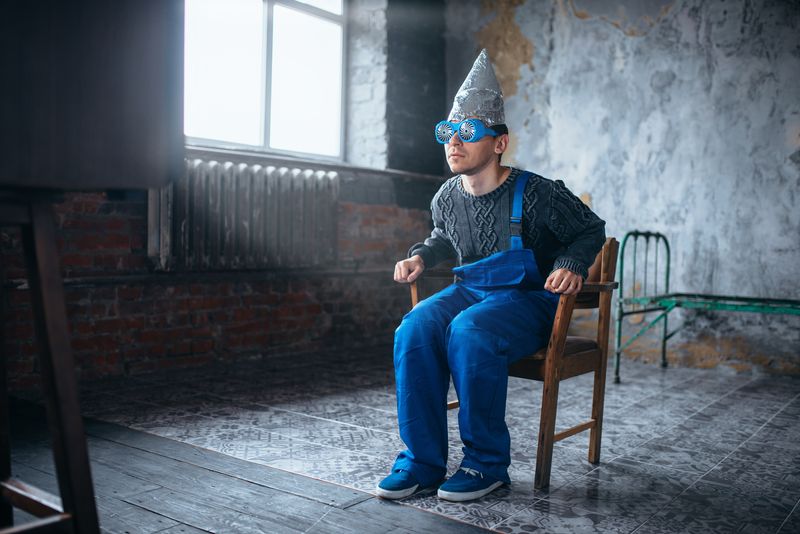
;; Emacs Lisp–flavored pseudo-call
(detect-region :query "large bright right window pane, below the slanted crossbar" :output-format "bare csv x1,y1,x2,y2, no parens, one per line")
269,6,342,156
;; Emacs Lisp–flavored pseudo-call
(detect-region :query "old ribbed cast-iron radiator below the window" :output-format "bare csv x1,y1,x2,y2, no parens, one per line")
148,159,339,270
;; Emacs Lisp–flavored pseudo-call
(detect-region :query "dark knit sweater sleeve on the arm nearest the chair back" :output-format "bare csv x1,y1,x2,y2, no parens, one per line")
547,180,606,279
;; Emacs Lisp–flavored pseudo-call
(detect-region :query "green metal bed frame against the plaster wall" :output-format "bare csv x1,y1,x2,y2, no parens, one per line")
614,230,800,384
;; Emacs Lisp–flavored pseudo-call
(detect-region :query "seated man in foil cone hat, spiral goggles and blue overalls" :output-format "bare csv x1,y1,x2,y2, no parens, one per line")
376,50,605,501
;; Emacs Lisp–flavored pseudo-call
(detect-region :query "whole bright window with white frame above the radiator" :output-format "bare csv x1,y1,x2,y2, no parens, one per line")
184,0,345,159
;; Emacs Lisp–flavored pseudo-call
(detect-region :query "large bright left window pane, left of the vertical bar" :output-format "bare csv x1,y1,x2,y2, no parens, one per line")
184,0,264,145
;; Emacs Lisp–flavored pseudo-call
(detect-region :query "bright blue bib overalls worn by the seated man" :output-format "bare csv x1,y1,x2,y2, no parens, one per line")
394,173,559,486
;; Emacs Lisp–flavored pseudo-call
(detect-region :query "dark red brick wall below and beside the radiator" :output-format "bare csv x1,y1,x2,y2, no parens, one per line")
0,171,436,390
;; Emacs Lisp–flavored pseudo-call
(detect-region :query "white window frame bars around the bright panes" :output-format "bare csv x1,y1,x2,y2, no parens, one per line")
185,0,348,163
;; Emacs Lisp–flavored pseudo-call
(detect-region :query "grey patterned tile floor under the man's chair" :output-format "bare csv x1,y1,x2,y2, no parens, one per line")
76,348,800,534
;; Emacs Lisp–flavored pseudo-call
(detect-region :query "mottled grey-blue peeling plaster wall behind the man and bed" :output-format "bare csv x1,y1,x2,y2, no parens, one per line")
446,0,800,372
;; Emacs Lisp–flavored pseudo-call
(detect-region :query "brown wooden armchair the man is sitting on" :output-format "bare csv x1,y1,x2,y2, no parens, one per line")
410,237,619,489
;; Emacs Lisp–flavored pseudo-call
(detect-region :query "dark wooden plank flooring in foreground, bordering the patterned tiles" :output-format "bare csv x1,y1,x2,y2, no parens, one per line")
12,402,484,534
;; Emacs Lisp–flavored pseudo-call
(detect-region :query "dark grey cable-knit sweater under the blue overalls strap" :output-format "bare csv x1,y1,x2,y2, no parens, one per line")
408,168,605,278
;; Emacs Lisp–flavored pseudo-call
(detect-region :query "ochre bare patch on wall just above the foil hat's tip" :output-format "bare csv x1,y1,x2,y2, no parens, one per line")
476,0,534,98
